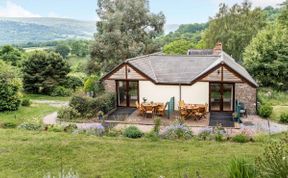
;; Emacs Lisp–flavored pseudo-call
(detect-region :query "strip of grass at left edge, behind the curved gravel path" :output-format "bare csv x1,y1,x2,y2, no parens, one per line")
0,104,57,126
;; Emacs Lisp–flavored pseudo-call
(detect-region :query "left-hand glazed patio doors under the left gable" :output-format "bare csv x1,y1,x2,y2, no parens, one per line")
116,80,139,107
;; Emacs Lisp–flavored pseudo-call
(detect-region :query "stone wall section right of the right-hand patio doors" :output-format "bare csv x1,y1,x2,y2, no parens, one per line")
235,83,257,114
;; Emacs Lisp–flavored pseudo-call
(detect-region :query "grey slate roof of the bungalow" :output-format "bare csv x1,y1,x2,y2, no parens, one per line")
103,50,258,87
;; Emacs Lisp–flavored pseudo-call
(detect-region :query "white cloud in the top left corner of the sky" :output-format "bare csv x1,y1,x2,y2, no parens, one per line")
0,1,40,17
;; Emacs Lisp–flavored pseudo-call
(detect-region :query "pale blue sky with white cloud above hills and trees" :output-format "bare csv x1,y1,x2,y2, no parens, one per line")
0,0,284,24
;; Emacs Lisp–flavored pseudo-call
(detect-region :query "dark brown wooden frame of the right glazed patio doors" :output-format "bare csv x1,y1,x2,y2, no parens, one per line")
209,81,235,112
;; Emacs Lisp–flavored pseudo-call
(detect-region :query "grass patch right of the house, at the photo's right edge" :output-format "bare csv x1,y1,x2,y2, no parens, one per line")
258,88,288,121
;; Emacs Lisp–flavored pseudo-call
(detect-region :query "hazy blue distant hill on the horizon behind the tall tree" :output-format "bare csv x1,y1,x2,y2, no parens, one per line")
0,17,179,45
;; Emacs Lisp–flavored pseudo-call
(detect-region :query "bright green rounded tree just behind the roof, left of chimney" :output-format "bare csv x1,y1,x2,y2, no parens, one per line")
163,40,195,55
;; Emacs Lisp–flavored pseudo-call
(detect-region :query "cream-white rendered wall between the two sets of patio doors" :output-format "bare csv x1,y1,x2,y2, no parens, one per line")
139,81,209,109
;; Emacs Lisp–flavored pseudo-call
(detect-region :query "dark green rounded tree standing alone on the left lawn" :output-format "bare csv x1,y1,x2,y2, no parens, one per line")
22,51,70,94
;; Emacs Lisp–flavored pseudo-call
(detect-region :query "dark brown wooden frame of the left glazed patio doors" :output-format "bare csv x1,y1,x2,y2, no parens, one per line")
115,80,139,108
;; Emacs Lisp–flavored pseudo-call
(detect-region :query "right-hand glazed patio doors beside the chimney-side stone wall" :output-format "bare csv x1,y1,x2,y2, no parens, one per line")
209,83,234,112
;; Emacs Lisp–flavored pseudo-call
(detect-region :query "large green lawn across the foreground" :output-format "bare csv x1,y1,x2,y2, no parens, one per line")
0,129,284,178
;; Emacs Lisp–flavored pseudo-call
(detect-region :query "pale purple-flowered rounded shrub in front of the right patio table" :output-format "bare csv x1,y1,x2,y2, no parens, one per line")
161,122,193,139
